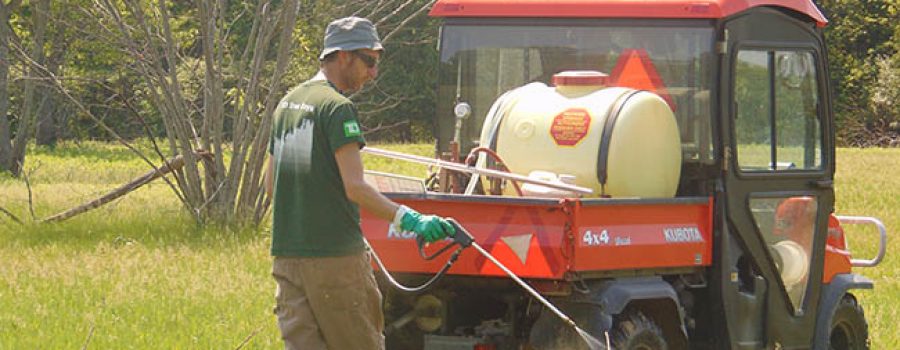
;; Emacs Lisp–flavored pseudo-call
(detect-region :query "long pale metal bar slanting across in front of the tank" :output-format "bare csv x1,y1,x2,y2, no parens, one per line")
362,147,594,194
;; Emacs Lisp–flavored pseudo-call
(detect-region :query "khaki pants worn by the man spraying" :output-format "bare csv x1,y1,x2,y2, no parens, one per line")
272,252,384,350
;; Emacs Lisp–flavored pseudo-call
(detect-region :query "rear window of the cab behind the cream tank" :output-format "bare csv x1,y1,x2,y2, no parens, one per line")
437,19,715,162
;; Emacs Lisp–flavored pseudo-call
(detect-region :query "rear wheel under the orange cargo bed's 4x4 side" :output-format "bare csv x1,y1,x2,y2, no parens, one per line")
610,312,669,350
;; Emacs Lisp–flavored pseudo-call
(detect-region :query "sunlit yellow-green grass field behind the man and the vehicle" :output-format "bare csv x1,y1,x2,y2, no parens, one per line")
0,143,900,349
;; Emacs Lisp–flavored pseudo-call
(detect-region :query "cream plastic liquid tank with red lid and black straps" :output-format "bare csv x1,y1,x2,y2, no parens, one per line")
481,71,681,197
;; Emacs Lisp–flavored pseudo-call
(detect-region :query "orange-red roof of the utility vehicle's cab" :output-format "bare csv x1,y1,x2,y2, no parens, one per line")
428,0,828,27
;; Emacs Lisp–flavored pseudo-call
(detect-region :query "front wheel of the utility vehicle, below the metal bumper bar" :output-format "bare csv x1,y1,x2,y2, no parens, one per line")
827,295,869,350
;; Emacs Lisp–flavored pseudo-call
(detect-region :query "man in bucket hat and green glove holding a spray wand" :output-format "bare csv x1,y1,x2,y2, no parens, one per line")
266,17,454,350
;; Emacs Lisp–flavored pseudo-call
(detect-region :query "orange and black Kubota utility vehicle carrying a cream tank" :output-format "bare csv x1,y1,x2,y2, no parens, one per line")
362,0,886,350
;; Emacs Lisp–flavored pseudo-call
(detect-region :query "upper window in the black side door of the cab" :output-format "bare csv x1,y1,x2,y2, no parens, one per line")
734,50,822,172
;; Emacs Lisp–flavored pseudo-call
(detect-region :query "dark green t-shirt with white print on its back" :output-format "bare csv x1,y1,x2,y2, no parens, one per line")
269,80,366,257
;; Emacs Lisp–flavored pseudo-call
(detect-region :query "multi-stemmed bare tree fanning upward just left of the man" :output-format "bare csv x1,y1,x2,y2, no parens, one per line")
69,0,300,222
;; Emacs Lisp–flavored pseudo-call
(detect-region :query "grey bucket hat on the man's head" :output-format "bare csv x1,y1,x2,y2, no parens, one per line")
319,16,384,60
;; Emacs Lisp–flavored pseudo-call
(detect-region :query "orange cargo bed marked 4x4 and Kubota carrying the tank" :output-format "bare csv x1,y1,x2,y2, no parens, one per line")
361,194,712,279
